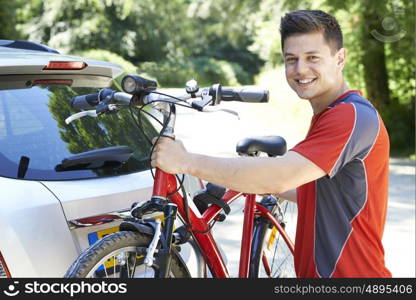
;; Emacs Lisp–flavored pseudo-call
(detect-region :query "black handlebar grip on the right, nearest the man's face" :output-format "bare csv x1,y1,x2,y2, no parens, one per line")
220,86,269,103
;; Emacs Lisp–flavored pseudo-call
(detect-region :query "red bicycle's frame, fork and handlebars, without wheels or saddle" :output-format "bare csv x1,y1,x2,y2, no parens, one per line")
65,82,294,278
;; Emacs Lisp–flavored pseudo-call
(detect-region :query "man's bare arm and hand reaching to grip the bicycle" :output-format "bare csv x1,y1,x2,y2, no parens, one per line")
151,138,325,193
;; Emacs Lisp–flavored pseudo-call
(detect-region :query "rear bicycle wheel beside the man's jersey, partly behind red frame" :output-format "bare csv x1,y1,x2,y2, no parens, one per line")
250,201,296,278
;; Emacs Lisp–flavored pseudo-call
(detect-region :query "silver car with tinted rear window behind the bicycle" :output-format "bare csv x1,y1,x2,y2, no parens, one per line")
0,40,201,278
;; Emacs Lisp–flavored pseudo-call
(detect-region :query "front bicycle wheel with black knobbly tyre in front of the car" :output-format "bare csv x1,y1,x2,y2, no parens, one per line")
64,231,190,278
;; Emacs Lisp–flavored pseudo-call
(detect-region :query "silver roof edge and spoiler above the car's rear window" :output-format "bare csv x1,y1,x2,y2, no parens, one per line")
0,40,123,78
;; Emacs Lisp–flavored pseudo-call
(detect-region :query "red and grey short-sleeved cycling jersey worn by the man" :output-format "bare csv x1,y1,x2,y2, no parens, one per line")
291,91,391,277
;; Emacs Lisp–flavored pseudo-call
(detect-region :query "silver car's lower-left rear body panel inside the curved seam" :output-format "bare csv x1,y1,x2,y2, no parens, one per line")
0,177,78,277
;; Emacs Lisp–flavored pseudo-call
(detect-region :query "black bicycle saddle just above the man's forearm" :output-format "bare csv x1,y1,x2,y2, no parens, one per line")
236,135,286,157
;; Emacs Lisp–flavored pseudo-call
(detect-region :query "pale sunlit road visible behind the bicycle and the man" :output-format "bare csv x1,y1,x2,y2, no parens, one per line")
171,99,415,277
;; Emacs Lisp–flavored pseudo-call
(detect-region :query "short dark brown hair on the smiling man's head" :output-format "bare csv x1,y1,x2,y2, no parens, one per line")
280,10,343,50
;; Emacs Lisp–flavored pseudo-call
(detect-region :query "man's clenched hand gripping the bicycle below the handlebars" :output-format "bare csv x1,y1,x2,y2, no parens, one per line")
151,137,191,174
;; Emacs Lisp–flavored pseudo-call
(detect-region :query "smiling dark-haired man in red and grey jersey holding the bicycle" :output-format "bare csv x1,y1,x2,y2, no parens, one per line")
152,10,391,277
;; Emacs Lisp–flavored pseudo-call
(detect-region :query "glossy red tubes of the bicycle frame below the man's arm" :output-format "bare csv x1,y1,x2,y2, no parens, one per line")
153,169,294,278
